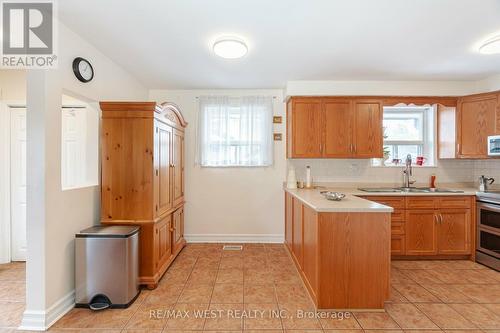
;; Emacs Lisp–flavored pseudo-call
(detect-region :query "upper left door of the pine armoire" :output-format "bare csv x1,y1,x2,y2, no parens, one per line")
155,121,173,216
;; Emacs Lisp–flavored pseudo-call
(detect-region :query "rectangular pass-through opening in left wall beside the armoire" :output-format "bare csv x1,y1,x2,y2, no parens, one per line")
61,98,99,190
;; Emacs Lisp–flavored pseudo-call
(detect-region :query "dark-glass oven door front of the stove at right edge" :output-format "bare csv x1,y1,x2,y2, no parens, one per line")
477,202,500,259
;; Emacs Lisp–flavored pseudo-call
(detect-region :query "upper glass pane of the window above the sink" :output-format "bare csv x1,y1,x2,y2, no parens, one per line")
384,112,424,141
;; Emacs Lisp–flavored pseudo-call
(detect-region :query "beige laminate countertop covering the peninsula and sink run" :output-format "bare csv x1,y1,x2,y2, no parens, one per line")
283,185,477,213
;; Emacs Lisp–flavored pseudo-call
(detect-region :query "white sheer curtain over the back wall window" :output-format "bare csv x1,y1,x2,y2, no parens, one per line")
197,96,273,167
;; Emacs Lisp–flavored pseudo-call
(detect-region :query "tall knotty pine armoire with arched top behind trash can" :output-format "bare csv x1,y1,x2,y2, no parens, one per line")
100,102,187,289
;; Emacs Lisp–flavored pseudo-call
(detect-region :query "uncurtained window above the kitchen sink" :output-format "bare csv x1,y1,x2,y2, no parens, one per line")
379,106,434,165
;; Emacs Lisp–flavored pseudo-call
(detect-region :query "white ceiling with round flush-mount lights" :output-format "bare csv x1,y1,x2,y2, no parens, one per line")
59,0,500,89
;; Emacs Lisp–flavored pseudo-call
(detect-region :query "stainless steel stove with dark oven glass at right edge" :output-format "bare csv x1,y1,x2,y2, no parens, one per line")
476,191,500,271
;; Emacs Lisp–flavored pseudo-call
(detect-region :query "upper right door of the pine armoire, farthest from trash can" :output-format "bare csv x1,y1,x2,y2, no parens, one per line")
172,129,184,206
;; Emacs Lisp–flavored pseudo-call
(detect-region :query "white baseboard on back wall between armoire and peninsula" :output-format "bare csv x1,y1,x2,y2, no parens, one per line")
184,234,285,243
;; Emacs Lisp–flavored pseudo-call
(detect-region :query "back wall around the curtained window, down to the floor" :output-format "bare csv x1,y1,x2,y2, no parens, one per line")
149,90,286,241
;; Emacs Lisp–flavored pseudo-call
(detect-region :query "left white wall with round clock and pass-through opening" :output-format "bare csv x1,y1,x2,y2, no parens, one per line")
22,24,148,329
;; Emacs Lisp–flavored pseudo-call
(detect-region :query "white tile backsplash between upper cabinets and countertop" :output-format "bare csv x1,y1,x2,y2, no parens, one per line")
287,159,500,186
